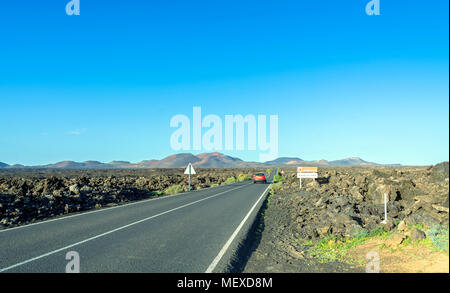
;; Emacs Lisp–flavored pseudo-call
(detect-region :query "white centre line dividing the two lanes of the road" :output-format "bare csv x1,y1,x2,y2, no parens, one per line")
0,184,250,273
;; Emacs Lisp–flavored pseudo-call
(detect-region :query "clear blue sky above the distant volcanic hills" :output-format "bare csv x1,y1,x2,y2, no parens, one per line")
0,0,449,165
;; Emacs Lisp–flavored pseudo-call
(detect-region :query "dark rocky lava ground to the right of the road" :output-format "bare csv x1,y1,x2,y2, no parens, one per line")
244,162,449,272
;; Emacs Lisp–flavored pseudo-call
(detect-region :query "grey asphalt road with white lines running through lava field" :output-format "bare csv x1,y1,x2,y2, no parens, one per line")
0,172,269,273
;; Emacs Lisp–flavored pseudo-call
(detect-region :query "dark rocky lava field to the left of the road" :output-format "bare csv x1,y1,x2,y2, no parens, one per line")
0,168,260,229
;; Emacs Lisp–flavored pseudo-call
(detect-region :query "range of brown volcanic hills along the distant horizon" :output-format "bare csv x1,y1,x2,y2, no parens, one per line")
0,152,398,169
